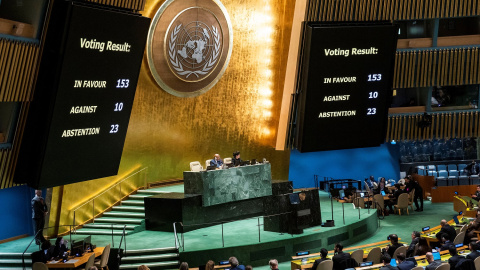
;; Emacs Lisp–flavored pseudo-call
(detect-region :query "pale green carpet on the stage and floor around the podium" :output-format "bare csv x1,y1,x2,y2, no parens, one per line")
0,188,455,270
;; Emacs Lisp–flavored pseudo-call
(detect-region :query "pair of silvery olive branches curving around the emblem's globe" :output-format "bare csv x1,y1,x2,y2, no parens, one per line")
168,24,220,78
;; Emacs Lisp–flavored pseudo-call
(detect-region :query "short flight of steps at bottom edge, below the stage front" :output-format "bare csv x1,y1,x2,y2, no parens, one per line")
120,247,180,270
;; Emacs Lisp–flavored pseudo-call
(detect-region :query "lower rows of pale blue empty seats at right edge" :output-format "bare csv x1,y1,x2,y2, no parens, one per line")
416,164,480,186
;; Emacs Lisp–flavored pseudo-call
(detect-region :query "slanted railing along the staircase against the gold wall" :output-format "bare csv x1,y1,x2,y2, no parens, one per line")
71,167,148,233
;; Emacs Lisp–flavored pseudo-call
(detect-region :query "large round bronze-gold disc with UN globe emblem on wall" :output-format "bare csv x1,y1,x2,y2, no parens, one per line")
147,0,233,97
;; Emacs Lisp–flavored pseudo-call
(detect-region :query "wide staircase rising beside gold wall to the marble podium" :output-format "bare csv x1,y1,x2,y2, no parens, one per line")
76,189,171,235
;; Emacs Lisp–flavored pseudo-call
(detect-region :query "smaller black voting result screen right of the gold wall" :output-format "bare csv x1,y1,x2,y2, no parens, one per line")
296,23,397,152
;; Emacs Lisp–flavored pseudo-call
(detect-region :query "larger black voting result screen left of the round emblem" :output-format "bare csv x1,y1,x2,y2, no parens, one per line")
17,1,150,187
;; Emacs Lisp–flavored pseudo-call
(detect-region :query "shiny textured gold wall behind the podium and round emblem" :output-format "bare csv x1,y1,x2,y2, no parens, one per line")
50,0,295,232
